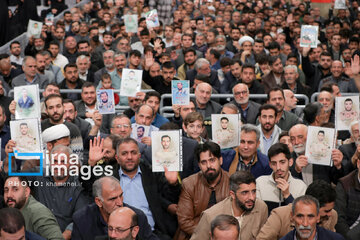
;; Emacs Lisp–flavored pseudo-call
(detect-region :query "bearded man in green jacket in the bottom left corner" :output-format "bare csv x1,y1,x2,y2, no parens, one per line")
2,176,63,239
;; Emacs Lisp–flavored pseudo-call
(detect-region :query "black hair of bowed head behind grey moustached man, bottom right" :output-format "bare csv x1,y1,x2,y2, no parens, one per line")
305,180,336,207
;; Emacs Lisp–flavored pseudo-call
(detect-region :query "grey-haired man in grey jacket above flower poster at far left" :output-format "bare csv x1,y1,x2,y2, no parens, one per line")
11,56,49,89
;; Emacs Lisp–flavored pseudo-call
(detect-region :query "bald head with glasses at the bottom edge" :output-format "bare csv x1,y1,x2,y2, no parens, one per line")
108,207,139,239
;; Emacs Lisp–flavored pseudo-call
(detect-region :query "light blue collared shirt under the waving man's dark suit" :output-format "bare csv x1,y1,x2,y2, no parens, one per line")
119,167,155,230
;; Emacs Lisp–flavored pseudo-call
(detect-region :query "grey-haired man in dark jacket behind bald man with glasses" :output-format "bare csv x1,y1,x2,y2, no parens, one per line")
71,176,158,240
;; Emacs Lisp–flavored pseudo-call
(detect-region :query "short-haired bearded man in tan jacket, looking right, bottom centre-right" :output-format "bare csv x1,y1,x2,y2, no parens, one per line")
191,171,268,240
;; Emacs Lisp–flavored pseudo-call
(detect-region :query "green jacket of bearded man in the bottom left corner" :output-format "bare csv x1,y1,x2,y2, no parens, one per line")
21,195,64,240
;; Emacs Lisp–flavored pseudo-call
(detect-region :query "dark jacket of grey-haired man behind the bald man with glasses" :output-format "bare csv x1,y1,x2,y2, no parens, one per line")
71,203,158,240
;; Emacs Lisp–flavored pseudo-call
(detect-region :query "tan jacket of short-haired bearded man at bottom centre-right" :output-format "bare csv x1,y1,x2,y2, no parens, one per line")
191,197,268,240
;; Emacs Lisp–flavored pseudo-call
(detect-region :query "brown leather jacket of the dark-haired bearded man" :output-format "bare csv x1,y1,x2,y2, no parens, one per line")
174,169,230,240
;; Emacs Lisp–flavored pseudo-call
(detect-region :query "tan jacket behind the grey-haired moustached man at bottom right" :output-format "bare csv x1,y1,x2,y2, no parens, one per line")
256,204,337,240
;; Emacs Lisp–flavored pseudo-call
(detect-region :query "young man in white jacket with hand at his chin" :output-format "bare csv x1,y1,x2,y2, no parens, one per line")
256,143,306,213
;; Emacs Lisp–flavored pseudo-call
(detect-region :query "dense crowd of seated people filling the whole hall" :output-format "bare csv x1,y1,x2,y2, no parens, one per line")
0,0,360,240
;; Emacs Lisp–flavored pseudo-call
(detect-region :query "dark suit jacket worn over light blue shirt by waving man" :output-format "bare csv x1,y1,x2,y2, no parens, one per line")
114,160,181,237
